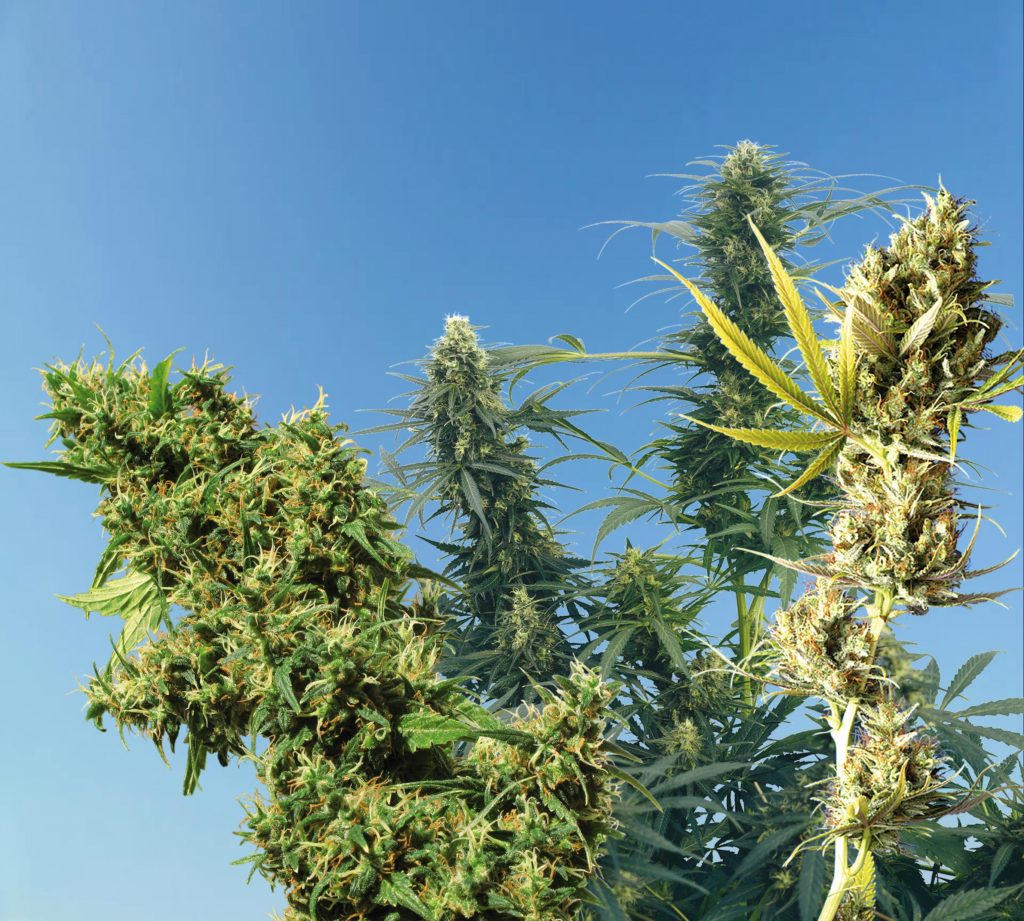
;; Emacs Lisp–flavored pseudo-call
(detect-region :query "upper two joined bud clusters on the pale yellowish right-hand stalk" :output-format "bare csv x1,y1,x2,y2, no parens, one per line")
831,190,1001,614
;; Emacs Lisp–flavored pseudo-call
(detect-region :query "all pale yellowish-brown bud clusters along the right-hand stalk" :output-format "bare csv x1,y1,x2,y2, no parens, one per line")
786,190,1016,921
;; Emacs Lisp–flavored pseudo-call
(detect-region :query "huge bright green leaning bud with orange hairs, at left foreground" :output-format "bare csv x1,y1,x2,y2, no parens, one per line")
37,354,614,921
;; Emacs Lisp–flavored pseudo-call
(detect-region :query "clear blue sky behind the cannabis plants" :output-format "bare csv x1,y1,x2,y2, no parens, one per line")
0,0,1024,921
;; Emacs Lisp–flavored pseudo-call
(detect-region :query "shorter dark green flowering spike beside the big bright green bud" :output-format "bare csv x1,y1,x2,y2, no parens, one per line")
370,317,583,700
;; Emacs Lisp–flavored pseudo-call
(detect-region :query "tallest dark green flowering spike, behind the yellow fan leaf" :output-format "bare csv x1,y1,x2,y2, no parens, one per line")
648,141,864,532
